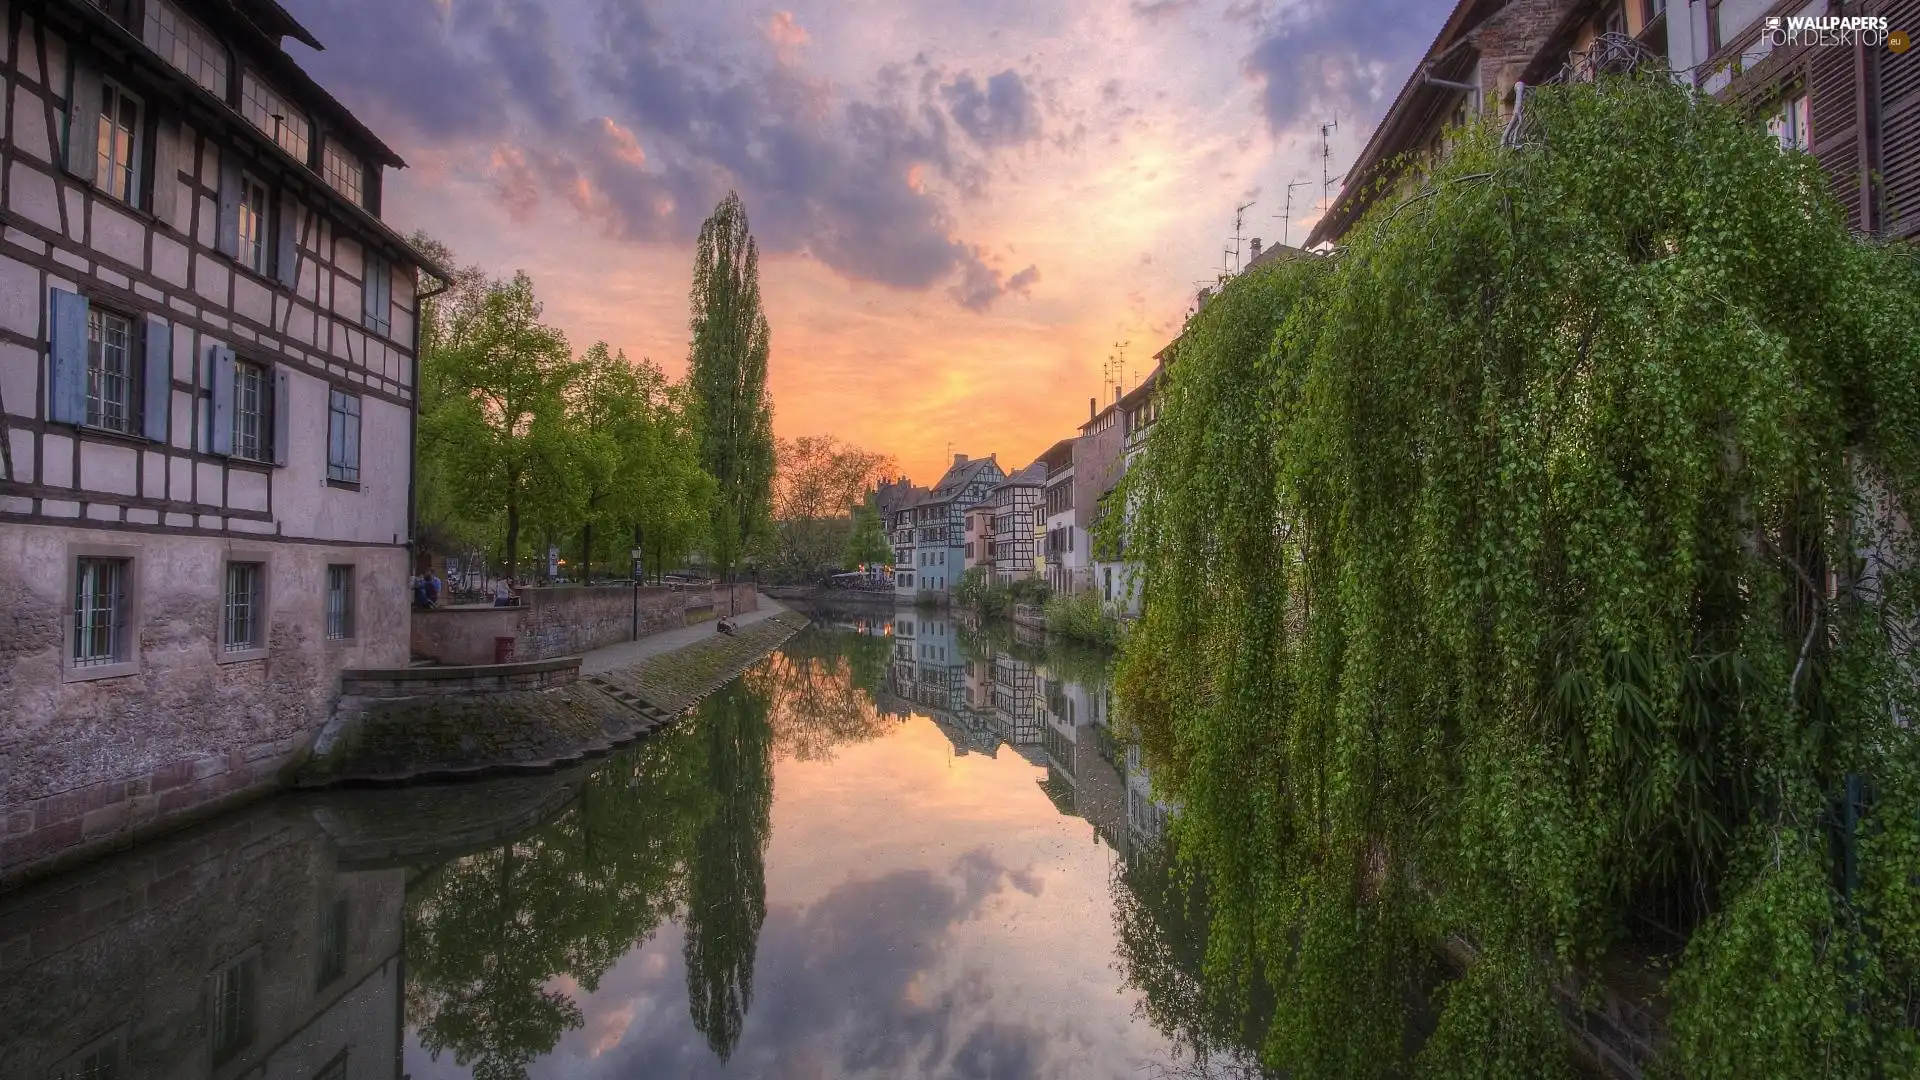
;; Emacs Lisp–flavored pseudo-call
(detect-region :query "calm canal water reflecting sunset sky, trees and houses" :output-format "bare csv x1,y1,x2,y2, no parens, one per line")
0,611,1248,1080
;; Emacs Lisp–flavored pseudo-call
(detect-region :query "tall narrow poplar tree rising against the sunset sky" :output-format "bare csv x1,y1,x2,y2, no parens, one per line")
687,192,774,573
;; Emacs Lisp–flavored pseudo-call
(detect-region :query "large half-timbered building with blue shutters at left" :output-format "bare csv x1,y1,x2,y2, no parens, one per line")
0,0,438,876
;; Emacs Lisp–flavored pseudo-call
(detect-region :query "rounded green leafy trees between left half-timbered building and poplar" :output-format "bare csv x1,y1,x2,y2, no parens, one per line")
415,236,714,571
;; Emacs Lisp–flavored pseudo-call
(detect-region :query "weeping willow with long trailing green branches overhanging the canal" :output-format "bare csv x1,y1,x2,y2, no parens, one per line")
1117,79,1920,1078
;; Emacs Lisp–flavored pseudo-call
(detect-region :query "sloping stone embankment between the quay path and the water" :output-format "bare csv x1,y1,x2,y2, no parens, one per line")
296,613,806,788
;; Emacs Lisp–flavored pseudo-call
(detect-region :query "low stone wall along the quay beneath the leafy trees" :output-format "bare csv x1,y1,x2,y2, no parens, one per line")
413,584,758,665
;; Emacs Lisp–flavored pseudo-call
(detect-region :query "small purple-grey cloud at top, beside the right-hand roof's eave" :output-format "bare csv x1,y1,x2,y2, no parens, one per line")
1242,0,1446,131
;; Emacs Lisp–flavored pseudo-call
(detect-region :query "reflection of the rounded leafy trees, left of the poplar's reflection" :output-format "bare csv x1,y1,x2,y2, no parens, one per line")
407,714,710,1080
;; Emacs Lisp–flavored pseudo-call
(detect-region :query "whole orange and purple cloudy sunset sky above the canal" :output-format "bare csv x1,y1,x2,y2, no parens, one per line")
284,0,1448,484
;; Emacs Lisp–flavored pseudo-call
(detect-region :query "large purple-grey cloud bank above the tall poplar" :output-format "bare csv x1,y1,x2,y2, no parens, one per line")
289,0,1041,311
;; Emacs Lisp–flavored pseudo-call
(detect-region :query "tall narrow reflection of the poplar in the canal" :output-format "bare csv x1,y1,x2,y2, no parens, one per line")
685,676,771,1061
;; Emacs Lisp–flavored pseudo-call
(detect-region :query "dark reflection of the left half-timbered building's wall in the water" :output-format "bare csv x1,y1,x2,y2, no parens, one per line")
0,803,407,1078
